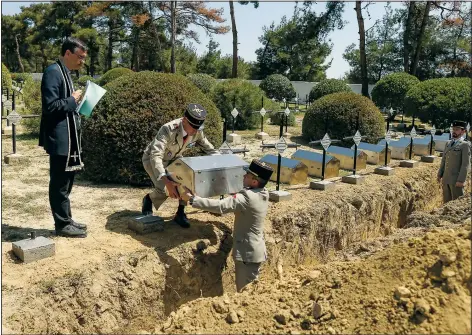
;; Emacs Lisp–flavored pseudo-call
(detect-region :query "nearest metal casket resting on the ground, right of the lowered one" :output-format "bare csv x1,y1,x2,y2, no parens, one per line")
260,155,308,185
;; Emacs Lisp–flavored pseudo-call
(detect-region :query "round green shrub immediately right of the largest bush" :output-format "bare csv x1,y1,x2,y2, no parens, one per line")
211,79,279,130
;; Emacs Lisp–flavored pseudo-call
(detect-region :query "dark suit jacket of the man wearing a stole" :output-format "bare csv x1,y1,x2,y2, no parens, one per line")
39,63,80,156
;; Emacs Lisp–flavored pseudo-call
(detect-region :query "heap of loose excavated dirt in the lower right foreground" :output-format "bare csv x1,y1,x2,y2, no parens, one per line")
160,225,471,334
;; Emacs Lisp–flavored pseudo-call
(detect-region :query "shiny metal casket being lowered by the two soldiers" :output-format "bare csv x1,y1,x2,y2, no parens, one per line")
167,155,249,197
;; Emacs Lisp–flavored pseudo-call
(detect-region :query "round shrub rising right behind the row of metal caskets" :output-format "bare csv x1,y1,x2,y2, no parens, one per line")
302,92,385,146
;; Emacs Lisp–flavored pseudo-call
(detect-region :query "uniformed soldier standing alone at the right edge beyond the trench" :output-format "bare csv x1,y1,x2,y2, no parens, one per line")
438,121,470,203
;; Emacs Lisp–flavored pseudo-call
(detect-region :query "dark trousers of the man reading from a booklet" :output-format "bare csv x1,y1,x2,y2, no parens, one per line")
49,155,75,229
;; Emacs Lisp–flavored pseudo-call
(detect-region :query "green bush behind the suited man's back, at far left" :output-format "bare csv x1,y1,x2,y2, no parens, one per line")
21,76,42,135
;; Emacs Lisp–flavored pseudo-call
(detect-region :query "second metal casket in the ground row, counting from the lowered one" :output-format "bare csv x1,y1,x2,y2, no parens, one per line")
292,150,339,179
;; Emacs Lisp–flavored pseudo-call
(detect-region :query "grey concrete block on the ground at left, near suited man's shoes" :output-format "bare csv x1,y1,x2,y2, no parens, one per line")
12,236,56,263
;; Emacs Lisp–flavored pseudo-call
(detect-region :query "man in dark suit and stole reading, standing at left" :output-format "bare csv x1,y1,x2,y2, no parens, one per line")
39,38,87,237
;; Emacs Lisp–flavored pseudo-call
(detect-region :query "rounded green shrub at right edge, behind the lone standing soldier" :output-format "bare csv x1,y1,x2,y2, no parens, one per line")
405,78,472,129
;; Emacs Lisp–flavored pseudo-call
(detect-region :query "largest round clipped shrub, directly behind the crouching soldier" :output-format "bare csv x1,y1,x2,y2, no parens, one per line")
82,71,222,185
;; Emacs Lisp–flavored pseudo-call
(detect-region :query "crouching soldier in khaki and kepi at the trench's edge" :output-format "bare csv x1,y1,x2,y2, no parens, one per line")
142,104,220,228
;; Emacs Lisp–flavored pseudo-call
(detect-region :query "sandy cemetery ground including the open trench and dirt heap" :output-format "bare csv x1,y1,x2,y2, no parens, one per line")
2,115,472,334
